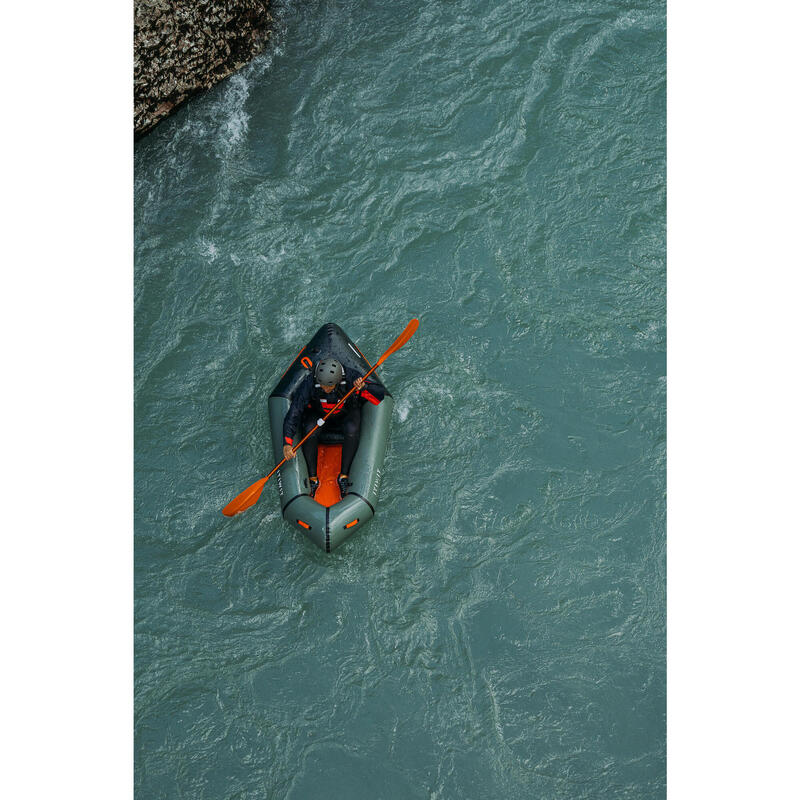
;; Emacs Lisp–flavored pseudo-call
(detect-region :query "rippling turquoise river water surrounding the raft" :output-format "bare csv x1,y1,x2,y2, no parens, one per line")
134,0,666,800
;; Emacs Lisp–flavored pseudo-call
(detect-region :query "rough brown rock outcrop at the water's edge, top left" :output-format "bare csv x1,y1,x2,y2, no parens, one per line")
133,0,272,137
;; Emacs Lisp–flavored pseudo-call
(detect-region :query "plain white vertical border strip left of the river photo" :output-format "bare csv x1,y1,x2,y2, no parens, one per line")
0,2,133,798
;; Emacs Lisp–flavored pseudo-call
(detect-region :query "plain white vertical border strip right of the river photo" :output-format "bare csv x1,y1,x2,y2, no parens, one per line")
667,1,798,799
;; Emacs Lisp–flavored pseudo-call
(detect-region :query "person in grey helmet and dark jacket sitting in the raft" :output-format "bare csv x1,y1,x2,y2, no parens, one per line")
283,358,385,497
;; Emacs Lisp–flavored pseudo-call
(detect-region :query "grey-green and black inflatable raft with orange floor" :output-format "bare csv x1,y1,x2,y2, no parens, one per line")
269,322,394,553
